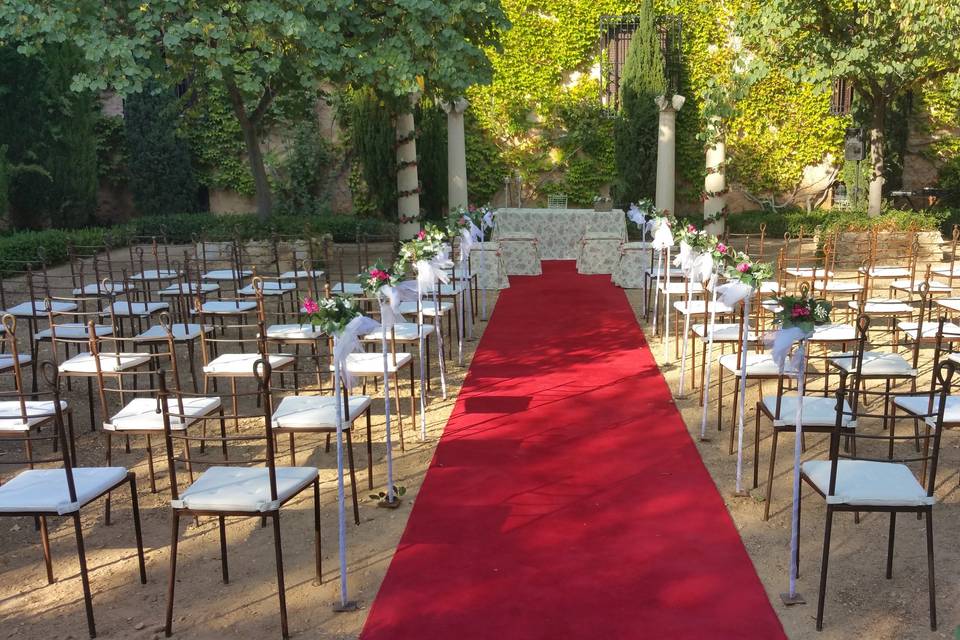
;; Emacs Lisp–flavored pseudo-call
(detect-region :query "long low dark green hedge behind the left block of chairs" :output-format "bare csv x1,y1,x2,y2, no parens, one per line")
0,213,395,273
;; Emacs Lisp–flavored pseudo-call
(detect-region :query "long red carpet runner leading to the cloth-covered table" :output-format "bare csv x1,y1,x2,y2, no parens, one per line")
362,262,784,640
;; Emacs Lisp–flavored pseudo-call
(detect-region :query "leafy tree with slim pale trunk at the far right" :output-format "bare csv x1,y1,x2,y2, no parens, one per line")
739,0,960,215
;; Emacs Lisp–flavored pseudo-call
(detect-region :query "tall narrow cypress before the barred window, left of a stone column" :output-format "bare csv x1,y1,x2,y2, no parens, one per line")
614,0,667,202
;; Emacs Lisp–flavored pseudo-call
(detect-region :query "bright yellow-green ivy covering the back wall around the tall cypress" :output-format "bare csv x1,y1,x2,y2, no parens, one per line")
470,0,846,210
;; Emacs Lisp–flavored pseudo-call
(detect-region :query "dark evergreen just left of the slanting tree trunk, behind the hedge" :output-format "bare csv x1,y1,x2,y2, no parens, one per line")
123,86,199,216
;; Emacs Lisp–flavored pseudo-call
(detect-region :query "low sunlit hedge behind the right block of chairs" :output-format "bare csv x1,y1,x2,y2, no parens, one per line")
727,209,960,238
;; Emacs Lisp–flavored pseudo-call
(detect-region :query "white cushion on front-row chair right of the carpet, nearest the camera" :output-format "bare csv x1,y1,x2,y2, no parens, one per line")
801,460,934,507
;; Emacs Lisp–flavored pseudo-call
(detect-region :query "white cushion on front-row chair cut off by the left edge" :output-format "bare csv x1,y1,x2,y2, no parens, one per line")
0,467,127,515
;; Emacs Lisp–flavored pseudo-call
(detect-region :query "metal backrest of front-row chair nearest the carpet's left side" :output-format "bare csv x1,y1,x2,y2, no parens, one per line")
158,358,277,501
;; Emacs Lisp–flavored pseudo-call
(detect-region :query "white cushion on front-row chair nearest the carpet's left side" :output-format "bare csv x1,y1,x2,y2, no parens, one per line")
170,467,318,513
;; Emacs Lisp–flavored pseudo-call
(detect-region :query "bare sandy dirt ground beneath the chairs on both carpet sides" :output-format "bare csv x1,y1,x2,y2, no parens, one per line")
0,248,960,640
